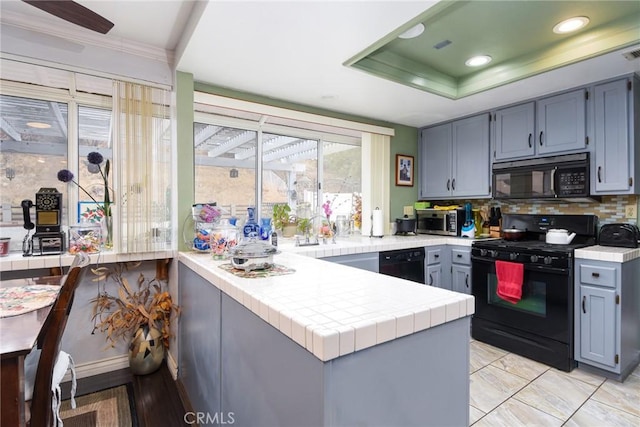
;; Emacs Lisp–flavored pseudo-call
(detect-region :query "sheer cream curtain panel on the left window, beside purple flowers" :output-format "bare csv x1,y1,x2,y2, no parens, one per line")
113,81,171,253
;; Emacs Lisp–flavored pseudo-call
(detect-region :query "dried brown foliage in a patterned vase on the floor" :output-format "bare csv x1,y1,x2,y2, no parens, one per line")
91,260,180,375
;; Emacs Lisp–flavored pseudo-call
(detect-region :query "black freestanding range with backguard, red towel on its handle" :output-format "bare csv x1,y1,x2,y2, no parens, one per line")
471,214,598,371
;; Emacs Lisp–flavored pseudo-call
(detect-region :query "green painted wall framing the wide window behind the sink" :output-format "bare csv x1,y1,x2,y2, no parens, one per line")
176,72,418,237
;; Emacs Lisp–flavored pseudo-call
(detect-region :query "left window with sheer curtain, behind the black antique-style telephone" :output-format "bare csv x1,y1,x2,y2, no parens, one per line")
0,59,172,252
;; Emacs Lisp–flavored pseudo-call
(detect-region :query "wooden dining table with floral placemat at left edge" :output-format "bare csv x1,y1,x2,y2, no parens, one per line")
0,276,65,426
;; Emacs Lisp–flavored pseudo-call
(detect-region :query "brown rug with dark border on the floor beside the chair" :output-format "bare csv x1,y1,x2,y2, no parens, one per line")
60,383,138,427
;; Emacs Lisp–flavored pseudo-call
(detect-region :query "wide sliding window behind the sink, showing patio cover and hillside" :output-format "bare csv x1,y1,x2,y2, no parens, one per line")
194,105,361,237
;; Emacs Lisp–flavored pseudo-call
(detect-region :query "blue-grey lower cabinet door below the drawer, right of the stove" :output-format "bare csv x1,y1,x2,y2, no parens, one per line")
580,285,616,367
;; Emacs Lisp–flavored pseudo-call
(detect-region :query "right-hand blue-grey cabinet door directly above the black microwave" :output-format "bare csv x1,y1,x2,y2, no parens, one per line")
536,89,587,154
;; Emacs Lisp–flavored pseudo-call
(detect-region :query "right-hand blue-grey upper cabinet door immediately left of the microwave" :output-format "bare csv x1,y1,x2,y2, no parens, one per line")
451,114,491,197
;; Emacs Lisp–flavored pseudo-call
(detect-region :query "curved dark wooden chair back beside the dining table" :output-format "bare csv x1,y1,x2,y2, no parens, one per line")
30,265,87,427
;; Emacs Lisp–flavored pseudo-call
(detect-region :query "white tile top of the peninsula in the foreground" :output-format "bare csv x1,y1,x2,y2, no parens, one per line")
179,252,474,361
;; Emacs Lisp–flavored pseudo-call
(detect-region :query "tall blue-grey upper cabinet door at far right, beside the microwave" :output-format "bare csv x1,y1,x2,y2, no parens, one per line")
593,79,633,194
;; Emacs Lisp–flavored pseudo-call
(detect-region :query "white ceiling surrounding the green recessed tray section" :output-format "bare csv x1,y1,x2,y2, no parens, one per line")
0,0,640,127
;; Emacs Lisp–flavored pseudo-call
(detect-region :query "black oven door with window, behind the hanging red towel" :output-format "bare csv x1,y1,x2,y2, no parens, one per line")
471,257,573,343
